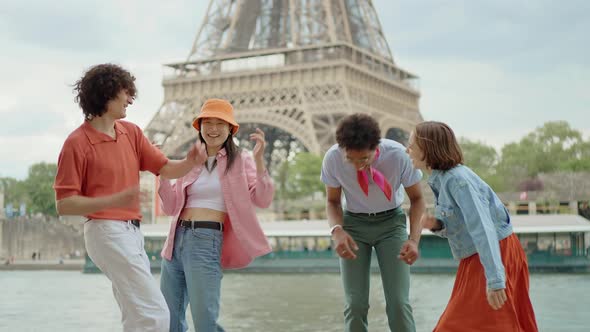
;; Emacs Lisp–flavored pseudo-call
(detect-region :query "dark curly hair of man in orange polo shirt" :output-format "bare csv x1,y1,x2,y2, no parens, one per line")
74,63,137,120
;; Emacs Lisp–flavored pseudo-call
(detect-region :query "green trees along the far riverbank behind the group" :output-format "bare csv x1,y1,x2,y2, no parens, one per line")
0,121,590,216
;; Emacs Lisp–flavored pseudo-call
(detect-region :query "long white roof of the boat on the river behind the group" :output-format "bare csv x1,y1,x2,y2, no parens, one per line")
141,214,590,237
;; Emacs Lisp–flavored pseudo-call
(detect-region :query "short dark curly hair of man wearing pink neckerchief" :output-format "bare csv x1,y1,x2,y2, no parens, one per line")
336,113,381,151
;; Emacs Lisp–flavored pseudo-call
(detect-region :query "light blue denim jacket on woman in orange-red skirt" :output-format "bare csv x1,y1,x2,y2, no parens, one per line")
428,165,512,289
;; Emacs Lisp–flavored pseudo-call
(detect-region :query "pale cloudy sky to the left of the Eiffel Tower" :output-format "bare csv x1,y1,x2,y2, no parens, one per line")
0,0,206,178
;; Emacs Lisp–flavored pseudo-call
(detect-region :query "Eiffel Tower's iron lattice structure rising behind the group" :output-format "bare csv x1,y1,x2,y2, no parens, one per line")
145,0,422,170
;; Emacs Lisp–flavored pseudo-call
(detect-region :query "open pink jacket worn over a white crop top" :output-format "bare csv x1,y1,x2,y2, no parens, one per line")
158,149,274,269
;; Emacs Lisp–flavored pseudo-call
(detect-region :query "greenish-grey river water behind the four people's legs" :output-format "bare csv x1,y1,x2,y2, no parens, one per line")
0,271,590,332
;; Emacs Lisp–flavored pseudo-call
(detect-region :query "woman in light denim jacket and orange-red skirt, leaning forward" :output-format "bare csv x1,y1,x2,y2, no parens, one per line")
407,121,538,332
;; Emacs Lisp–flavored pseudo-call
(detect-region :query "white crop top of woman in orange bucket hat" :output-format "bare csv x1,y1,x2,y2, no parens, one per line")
185,156,227,212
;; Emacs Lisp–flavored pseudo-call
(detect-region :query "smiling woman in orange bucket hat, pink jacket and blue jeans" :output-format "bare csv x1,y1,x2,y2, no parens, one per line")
158,99,274,332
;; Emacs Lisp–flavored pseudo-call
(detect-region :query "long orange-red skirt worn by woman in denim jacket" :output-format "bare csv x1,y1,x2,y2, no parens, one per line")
434,234,538,332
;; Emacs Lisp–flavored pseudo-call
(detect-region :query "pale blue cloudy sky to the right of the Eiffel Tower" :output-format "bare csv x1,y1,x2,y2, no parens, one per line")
375,0,590,148
